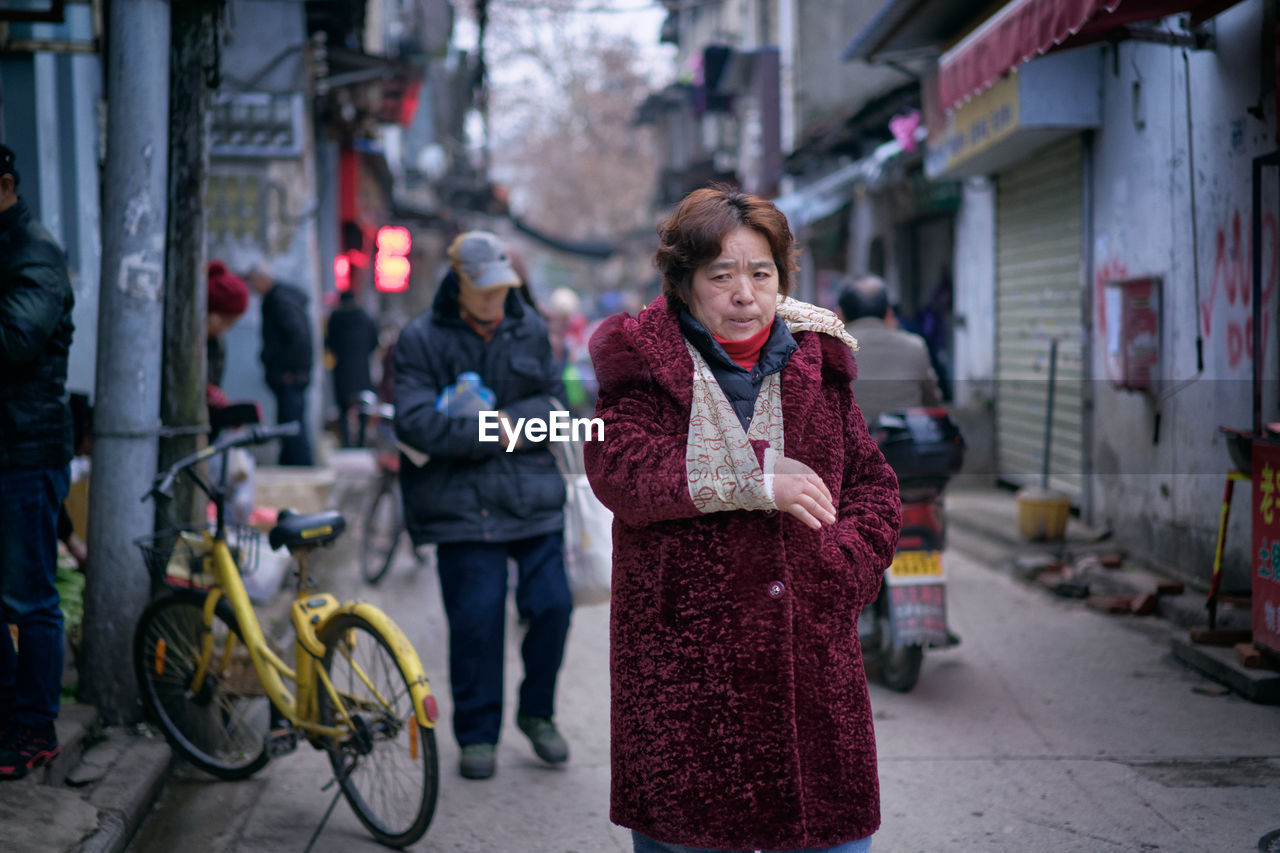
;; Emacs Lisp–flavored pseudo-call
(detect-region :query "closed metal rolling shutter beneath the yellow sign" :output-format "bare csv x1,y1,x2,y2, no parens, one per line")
996,136,1084,503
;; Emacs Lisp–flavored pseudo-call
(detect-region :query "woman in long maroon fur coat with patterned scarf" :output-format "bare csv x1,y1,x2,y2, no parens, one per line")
586,187,901,853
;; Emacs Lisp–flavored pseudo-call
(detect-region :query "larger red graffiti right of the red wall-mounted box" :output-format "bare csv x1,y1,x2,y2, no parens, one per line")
1201,211,1280,370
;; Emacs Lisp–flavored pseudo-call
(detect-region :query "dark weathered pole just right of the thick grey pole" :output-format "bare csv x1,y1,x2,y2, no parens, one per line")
156,0,221,529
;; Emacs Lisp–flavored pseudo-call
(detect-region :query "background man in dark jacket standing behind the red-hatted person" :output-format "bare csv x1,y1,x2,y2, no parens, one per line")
246,264,312,465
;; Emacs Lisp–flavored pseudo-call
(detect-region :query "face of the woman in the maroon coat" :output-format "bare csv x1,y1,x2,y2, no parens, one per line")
689,225,778,341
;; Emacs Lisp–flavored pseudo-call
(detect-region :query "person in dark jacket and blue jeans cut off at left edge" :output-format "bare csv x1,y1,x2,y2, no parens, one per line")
0,145,74,779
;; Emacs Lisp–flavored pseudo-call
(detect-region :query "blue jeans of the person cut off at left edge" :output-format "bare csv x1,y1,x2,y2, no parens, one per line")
0,466,70,727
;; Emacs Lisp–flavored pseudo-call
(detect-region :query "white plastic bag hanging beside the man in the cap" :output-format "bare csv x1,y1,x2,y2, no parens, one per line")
556,443,613,607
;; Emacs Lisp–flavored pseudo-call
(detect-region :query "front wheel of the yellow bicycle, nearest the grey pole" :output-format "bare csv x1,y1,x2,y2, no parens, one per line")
133,590,271,779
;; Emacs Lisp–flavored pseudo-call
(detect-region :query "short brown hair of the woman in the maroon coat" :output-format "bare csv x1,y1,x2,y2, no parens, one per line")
653,184,799,307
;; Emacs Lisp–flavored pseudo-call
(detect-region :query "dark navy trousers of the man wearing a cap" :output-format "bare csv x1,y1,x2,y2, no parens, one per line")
436,533,573,747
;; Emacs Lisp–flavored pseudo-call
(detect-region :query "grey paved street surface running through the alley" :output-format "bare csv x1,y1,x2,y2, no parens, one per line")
131,522,1280,853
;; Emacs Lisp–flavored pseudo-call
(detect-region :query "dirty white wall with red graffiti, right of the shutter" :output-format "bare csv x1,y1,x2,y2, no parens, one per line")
1087,0,1280,588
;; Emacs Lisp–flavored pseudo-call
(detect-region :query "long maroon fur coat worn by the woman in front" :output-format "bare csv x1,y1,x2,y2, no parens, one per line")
586,298,901,850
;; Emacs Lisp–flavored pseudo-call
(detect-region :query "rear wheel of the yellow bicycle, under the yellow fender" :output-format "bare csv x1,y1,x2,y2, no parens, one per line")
319,613,440,847
